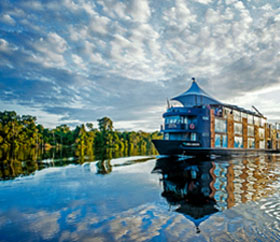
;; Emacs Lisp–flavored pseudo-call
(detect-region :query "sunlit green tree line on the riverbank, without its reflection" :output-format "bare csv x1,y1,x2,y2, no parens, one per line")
0,111,161,154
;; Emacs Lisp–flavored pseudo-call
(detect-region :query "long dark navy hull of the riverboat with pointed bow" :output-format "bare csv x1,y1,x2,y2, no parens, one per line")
152,140,280,156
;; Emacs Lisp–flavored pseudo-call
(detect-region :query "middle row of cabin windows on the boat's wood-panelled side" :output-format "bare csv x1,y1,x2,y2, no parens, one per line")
215,118,265,139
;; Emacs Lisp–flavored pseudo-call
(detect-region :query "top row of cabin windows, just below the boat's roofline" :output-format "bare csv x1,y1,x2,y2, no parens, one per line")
218,107,266,126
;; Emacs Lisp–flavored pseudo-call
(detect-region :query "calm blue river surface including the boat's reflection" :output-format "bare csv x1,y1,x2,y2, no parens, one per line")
0,152,280,241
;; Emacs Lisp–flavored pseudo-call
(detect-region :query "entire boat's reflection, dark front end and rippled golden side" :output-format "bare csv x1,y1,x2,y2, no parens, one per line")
153,155,280,231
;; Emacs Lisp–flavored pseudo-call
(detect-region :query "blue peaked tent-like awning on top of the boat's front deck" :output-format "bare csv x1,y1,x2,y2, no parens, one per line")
171,78,222,107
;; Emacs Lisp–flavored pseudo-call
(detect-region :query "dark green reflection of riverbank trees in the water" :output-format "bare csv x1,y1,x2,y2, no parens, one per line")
0,147,154,180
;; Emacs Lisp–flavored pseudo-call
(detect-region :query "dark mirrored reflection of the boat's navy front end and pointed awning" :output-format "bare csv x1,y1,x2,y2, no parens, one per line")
152,157,219,233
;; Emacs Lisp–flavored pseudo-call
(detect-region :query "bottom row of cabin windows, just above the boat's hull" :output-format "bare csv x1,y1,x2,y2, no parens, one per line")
215,134,265,149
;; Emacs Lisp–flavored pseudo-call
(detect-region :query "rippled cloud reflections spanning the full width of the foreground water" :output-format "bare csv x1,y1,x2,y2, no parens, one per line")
0,196,280,242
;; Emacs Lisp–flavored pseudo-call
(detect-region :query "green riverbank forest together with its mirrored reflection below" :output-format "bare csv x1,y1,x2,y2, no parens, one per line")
0,111,161,180
